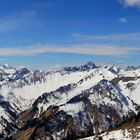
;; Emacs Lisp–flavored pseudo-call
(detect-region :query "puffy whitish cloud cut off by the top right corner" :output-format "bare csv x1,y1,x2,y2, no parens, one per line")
120,0,140,7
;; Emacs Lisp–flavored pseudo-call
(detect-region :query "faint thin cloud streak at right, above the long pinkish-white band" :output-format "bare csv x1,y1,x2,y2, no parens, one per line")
72,32,140,41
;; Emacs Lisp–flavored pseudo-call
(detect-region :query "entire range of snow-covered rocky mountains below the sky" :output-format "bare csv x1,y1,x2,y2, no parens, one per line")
0,62,140,140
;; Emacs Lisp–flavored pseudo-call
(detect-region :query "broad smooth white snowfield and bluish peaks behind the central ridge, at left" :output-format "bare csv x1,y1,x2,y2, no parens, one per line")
0,63,95,110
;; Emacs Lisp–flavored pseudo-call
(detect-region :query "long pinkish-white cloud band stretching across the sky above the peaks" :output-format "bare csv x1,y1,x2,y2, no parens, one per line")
0,44,140,57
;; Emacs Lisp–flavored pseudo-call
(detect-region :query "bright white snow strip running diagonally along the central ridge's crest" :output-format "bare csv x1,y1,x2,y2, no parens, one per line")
34,68,115,115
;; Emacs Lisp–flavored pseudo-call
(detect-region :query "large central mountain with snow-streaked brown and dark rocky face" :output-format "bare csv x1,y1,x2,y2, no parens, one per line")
15,77,137,139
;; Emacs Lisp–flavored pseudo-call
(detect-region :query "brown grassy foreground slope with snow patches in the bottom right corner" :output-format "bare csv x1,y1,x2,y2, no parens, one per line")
80,113,140,140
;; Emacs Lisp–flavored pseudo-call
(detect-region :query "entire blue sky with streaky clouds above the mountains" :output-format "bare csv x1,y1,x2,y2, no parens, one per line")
0,0,140,69
